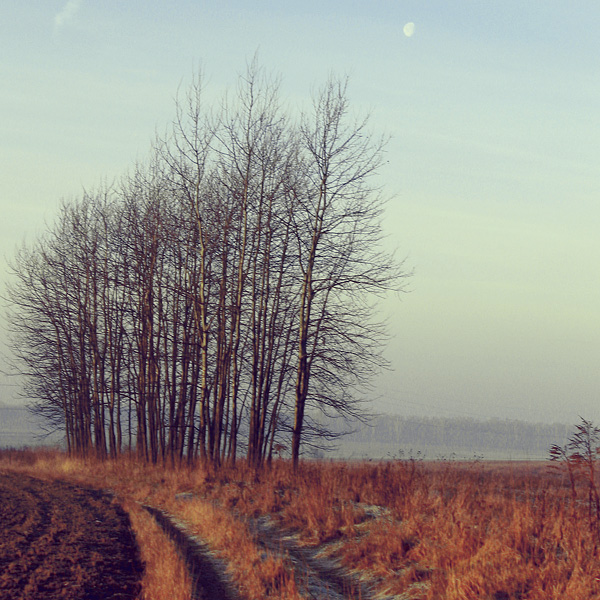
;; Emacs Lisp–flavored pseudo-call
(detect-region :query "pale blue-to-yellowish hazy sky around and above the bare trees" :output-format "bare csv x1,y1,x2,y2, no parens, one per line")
0,0,600,423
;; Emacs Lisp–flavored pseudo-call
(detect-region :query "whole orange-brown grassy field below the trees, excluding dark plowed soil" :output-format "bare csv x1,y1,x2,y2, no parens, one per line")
0,450,600,600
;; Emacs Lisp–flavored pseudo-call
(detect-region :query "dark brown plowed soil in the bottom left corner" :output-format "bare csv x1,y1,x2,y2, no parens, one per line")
0,472,143,600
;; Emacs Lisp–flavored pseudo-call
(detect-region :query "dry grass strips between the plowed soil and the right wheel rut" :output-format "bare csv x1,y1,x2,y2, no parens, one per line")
0,451,301,600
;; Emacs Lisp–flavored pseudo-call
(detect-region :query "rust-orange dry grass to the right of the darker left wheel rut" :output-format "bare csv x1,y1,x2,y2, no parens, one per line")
0,453,600,600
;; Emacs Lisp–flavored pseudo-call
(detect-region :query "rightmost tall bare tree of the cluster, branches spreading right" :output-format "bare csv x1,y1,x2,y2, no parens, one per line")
291,78,402,467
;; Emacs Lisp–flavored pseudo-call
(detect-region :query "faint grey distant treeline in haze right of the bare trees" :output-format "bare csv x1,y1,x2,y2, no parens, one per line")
326,415,573,458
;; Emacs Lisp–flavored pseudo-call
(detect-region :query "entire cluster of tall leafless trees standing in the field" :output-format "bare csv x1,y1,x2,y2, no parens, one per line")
9,64,403,465
